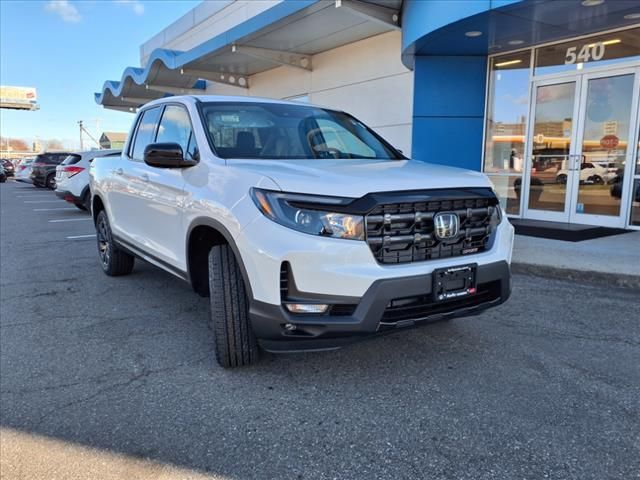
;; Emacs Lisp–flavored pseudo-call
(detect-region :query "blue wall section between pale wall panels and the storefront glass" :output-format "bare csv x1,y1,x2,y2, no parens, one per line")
411,56,487,170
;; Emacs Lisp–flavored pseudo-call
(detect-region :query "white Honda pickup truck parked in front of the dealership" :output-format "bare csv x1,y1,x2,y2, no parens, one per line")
90,96,513,367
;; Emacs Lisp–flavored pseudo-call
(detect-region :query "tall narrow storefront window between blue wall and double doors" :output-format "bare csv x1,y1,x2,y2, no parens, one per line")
484,50,531,215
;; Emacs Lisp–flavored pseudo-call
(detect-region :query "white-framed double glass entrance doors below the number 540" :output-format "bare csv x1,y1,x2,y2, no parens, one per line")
525,68,640,227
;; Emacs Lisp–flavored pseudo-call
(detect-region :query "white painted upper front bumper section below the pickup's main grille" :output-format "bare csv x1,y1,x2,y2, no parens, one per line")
235,214,514,306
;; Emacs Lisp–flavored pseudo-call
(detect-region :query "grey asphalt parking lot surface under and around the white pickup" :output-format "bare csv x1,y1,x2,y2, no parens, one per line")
0,182,640,480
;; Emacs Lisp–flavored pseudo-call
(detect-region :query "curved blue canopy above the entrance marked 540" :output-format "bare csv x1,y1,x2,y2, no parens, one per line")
402,0,640,69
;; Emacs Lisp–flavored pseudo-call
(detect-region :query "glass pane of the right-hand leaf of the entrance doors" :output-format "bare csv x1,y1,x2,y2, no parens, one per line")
576,74,634,216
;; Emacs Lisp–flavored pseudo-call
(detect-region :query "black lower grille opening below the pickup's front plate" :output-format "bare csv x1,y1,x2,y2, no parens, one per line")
380,280,500,325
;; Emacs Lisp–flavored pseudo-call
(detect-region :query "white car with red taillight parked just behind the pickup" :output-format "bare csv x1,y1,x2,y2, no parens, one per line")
55,150,121,210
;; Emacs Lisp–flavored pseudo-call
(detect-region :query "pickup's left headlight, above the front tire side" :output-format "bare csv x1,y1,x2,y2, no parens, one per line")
251,188,364,240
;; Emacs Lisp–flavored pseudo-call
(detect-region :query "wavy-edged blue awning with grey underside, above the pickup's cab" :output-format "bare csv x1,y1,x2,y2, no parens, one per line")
95,0,402,111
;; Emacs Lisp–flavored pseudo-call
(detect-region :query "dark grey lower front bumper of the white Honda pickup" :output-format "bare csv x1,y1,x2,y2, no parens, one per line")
249,261,511,352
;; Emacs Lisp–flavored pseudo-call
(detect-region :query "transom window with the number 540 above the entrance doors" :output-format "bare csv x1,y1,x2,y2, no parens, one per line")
534,28,640,76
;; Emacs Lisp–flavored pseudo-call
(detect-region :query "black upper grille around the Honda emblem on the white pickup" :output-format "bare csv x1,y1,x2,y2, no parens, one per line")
366,192,499,264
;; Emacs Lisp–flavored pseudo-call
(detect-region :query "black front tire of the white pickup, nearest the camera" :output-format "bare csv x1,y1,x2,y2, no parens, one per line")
209,245,258,368
